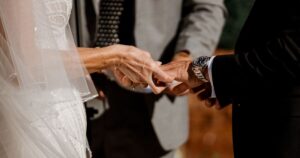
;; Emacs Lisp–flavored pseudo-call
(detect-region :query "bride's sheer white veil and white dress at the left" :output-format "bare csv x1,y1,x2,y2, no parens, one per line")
0,0,97,158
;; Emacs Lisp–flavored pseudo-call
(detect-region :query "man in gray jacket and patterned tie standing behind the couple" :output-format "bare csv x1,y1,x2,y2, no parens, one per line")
71,0,225,158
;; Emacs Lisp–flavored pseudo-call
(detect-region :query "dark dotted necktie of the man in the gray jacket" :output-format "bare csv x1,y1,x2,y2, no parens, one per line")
95,0,124,47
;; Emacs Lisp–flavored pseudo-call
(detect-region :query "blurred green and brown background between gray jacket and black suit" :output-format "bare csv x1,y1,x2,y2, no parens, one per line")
177,0,254,158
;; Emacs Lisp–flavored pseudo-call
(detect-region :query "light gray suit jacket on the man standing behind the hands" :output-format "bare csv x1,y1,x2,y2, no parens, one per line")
71,0,226,150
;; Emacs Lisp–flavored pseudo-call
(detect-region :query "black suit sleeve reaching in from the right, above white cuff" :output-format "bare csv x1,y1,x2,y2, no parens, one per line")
212,28,300,105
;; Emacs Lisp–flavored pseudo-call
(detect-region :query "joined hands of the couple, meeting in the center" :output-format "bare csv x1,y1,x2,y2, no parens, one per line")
96,45,215,106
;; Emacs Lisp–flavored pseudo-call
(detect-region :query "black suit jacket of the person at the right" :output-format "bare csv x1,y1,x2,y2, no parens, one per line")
212,0,300,158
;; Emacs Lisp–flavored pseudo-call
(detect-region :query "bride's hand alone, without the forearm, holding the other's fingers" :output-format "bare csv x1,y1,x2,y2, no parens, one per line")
106,46,173,94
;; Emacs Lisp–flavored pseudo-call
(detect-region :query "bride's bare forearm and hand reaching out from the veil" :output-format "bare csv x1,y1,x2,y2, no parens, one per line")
78,45,173,93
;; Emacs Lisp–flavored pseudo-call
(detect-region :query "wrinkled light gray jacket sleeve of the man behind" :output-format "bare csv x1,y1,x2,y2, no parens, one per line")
176,0,226,57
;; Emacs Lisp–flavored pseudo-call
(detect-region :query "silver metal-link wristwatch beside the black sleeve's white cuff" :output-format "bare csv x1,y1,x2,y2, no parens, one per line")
192,56,210,82
